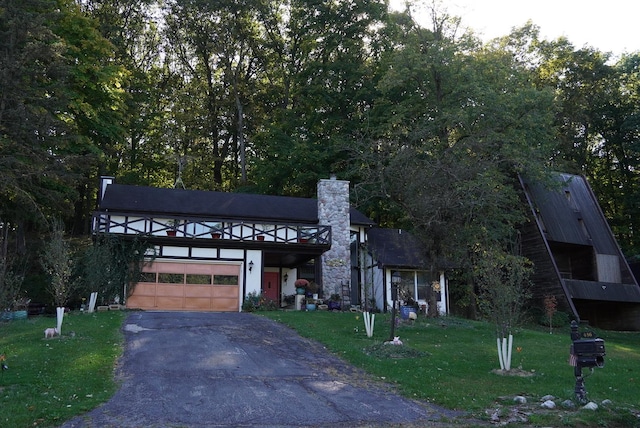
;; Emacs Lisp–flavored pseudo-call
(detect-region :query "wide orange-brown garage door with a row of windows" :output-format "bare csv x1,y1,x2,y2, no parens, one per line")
127,262,240,312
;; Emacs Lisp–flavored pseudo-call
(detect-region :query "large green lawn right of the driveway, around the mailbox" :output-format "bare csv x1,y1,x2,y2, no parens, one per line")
260,311,640,427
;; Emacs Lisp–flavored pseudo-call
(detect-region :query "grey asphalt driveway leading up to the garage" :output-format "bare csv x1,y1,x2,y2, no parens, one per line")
63,312,458,428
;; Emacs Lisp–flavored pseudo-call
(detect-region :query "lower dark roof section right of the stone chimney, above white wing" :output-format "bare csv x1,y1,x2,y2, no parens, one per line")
367,227,426,269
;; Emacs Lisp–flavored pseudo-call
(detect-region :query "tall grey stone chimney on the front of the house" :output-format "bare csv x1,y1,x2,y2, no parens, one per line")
318,176,351,304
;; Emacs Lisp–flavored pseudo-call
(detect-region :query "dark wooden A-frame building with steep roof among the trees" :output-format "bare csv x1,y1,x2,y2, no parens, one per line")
521,173,640,330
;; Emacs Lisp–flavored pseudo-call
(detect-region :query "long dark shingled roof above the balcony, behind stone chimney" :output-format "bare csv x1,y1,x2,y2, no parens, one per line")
99,184,374,225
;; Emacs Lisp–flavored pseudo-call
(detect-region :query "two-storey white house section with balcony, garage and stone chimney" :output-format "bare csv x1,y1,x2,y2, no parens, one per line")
93,177,384,311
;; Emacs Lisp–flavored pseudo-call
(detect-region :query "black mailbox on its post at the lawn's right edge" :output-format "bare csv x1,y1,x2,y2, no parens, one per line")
569,320,606,403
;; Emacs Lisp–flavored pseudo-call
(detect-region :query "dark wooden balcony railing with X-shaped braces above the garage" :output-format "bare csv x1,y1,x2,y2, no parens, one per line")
92,212,331,245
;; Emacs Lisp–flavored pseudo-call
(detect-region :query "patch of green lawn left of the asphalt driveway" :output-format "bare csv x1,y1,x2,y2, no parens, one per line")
0,311,125,427
